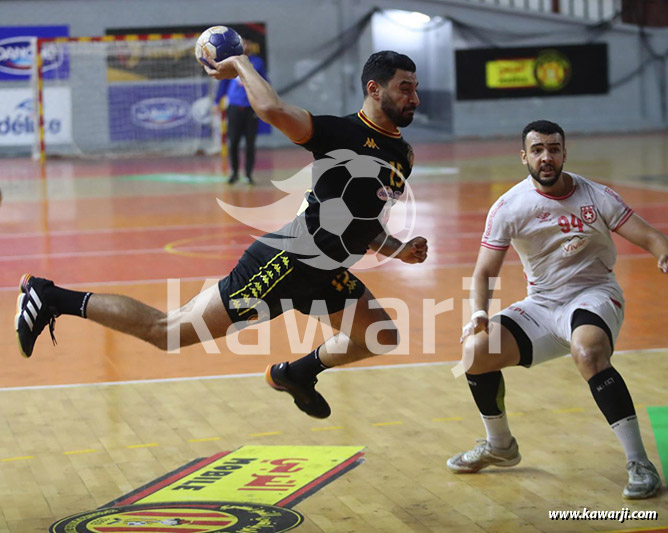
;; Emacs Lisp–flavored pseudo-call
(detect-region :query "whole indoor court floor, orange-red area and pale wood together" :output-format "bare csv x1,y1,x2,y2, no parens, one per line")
0,134,668,533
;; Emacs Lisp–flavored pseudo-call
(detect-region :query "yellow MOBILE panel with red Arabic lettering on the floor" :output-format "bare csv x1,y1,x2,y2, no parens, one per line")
134,446,364,505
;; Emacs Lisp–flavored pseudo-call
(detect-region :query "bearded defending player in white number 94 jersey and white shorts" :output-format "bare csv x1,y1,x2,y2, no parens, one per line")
447,120,668,499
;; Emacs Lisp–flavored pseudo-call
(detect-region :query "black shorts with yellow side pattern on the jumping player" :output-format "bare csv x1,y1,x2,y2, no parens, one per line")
218,241,366,322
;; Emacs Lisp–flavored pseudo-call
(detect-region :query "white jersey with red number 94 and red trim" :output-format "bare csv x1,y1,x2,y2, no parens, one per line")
482,172,633,301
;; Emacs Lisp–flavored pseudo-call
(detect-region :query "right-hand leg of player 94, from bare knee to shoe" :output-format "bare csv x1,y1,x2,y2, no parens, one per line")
571,324,661,499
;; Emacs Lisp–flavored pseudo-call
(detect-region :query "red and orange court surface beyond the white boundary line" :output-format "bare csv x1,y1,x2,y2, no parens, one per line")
0,137,668,387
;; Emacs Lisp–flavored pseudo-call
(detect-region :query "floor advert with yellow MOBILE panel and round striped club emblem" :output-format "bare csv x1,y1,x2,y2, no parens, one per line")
49,445,364,533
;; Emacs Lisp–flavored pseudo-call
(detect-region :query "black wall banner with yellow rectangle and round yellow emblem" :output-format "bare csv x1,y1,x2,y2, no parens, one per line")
455,44,608,100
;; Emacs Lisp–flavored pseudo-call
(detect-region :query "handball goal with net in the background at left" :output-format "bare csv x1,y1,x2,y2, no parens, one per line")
31,34,220,158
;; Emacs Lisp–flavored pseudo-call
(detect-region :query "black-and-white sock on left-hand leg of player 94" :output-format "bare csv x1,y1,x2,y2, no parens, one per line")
466,370,513,448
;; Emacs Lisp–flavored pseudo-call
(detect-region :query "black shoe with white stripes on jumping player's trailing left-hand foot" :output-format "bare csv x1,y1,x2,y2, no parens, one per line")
16,274,58,357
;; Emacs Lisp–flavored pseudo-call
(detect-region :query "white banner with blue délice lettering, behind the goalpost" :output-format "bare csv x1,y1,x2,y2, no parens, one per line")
0,87,72,146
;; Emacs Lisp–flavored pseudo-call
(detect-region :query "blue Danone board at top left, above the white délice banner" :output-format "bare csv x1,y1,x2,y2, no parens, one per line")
0,26,69,81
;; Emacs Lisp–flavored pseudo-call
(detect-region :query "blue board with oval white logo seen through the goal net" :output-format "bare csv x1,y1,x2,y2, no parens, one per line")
109,80,212,141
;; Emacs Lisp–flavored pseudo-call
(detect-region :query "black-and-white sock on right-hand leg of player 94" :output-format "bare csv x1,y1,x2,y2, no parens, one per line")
588,367,647,462
